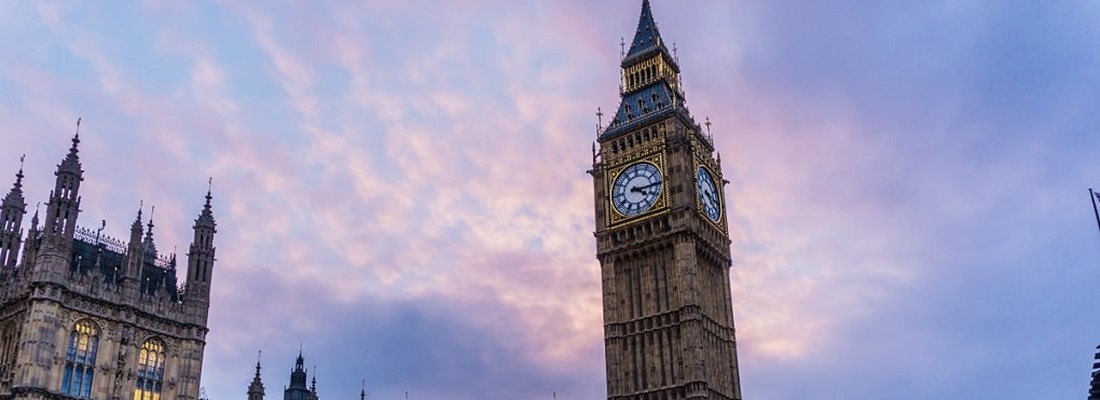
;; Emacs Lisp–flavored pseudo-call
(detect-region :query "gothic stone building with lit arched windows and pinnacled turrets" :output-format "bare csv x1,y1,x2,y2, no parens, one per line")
0,124,216,400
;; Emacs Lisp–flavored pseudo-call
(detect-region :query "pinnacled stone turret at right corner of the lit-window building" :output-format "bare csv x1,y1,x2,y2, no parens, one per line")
186,184,216,320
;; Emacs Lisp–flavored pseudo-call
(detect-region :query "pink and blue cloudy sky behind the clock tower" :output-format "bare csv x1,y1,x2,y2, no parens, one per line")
0,0,1100,400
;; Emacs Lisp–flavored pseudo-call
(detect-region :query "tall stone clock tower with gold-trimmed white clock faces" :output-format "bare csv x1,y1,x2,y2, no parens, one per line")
591,0,741,400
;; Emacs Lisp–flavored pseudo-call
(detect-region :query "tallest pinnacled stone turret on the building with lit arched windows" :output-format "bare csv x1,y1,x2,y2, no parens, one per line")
43,126,84,241
